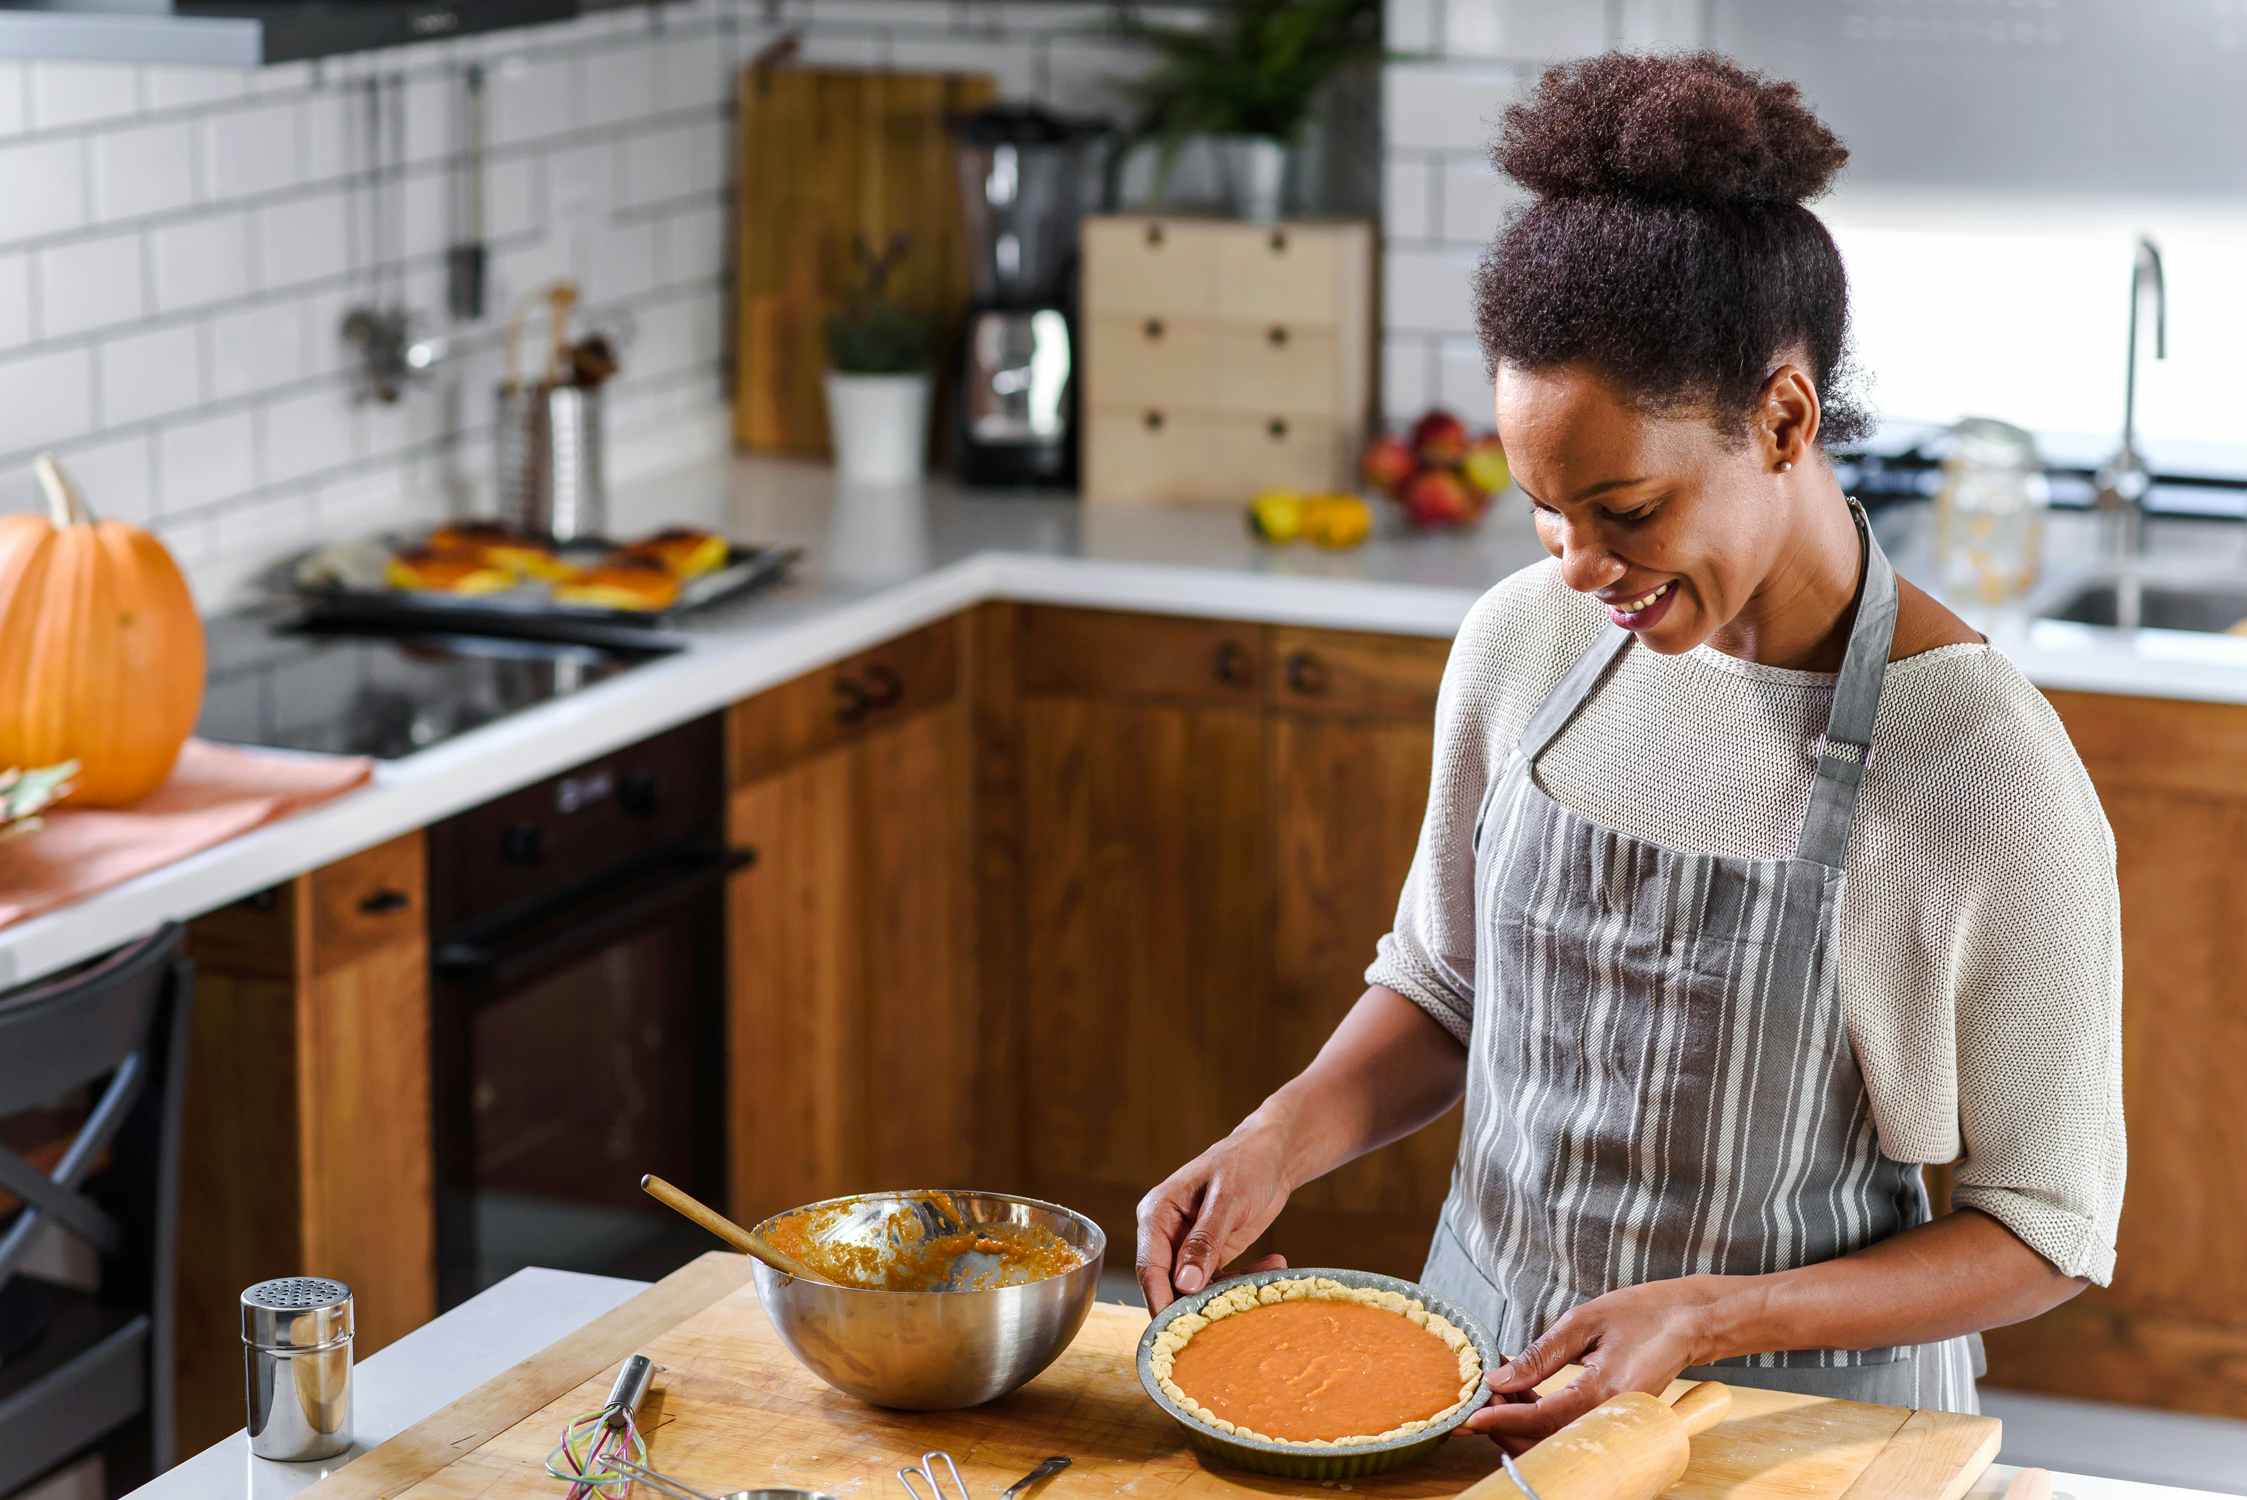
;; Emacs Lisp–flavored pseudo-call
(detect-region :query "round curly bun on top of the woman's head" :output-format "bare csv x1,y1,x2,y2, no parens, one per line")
1490,52,1849,204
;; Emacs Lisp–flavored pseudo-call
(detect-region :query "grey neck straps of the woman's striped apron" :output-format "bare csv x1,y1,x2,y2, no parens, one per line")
1519,496,1896,869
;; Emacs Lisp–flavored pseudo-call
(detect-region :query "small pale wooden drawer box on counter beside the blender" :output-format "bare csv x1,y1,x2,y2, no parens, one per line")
1083,218,1373,505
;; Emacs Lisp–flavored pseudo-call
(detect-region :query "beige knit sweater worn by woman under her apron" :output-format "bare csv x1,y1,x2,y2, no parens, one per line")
1366,561,2126,1284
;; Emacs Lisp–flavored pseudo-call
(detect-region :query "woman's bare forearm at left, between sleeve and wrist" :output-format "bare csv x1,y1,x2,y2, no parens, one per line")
1240,984,1467,1192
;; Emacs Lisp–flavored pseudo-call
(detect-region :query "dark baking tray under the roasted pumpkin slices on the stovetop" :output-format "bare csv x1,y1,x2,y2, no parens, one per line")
274,537,804,633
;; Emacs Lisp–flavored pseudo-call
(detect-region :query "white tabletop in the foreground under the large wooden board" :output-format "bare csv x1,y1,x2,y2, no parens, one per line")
133,1269,2216,1500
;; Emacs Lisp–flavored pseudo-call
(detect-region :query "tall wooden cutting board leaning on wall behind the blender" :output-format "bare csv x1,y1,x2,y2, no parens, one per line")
733,65,993,454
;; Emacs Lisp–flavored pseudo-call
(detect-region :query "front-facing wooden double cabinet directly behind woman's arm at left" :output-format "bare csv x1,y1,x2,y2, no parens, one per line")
1020,609,1456,1273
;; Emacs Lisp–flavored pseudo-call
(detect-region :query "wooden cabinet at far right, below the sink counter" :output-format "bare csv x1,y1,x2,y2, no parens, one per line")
1986,694,2247,1417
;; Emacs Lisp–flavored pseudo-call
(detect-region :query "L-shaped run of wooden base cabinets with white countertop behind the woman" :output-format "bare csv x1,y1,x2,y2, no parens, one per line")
17,460,2247,1442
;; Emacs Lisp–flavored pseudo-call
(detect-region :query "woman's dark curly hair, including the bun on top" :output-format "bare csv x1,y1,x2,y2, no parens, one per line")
1474,52,1872,447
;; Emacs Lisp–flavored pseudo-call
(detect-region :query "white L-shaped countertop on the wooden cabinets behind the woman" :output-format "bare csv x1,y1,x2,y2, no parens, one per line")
0,458,2247,988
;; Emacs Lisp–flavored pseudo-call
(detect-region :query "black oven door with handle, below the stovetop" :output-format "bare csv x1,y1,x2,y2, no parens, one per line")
429,849,753,1307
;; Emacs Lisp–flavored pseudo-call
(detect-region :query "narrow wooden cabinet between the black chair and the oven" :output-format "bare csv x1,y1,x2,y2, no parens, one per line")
178,833,436,1453
